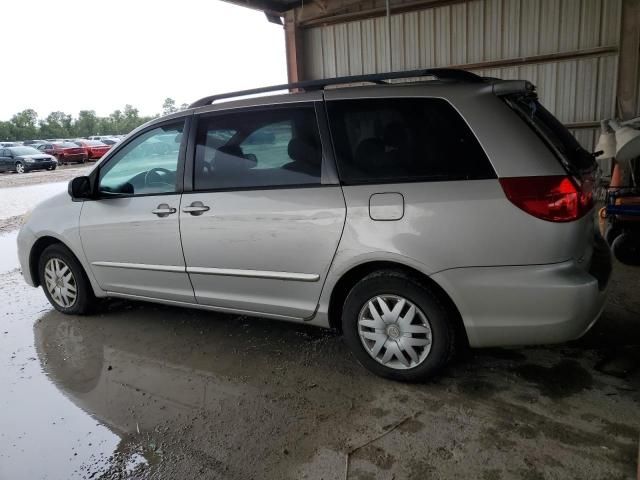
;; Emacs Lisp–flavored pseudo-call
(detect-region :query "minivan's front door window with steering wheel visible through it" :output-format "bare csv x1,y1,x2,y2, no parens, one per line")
99,122,184,196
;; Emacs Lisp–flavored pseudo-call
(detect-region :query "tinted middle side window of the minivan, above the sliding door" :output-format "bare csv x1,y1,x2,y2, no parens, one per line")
194,106,322,190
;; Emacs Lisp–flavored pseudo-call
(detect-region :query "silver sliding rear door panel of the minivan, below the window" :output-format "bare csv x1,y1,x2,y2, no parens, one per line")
180,186,345,318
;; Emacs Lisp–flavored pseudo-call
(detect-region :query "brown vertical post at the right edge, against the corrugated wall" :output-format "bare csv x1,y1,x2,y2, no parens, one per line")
617,0,640,120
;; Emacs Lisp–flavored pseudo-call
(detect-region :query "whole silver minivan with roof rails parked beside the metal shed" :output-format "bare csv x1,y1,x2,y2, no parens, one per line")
18,69,611,381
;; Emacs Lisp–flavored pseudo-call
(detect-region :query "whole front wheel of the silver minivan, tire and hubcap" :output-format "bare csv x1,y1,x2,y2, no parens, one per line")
38,243,97,315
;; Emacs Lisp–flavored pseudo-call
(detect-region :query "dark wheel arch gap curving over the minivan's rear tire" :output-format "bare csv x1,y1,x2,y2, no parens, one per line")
328,260,469,347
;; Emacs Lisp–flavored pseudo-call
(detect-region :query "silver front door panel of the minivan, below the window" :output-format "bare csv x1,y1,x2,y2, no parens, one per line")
80,194,195,302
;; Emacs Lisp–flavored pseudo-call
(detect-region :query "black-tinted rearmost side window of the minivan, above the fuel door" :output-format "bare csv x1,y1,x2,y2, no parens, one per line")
327,98,496,184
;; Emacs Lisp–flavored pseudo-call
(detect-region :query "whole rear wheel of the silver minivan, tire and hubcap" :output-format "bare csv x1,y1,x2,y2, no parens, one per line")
342,270,456,382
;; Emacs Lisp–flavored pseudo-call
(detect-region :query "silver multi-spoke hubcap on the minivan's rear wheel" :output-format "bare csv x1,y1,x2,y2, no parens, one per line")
358,295,432,370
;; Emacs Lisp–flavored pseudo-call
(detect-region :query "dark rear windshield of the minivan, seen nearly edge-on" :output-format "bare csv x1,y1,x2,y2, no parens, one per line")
505,95,596,174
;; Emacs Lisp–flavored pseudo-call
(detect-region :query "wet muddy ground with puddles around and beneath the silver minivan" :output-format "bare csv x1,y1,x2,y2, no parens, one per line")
0,172,640,480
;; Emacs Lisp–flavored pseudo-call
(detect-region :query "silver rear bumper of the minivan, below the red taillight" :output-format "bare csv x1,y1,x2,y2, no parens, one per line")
432,251,610,347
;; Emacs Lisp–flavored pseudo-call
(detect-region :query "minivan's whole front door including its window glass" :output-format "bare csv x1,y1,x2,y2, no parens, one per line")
80,120,195,302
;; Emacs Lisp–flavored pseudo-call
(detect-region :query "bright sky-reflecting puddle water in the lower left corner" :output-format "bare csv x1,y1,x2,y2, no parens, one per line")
0,272,120,479
